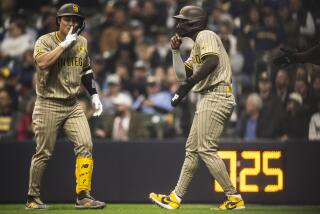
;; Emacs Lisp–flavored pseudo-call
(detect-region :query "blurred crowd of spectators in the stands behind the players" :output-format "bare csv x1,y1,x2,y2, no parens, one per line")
0,0,320,142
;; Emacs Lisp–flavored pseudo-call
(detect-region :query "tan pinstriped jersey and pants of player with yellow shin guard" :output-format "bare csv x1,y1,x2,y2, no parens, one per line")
28,32,92,196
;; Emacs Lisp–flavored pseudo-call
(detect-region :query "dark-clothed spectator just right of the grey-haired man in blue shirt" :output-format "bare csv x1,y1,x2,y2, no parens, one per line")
257,71,285,138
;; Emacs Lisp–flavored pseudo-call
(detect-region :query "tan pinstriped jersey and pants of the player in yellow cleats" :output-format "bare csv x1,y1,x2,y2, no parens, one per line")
175,30,236,197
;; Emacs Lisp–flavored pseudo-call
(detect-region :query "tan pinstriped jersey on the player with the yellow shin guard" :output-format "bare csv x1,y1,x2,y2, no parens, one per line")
34,32,90,99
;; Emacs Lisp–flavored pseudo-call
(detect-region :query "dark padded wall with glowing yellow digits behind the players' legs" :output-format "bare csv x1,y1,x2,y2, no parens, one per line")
0,140,320,204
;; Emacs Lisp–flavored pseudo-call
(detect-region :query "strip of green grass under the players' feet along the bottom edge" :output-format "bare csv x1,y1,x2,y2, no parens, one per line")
0,204,320,214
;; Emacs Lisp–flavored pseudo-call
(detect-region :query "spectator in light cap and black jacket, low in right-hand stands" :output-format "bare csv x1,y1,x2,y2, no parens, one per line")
280,92,309,140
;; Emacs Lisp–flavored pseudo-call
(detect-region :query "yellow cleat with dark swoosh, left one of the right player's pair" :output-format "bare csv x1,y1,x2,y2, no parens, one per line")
149,192,181,210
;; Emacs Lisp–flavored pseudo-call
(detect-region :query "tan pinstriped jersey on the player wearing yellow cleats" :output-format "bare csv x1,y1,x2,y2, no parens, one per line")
185,30,231,92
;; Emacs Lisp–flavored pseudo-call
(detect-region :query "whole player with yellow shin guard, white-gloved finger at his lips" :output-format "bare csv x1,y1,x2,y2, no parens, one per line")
25,4,105,209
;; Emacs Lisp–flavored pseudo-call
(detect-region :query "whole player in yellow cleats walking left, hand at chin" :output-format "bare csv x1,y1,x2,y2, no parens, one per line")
149,6,245,210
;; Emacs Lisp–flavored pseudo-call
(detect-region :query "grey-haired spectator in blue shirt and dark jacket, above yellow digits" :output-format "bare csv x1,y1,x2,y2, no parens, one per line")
235,93,263,141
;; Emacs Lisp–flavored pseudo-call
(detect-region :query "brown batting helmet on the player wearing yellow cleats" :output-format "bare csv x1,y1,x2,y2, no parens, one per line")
173,5,208,37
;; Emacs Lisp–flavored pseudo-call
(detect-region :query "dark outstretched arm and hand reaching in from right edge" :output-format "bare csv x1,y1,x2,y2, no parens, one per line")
273,42,320,67
